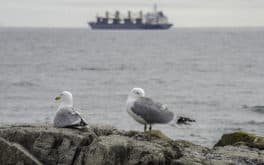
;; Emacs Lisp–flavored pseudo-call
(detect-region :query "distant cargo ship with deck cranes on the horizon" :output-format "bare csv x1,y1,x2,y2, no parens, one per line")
88,4,173,30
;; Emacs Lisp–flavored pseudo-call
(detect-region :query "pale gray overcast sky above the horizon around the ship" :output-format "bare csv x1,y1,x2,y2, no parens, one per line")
0,0,264,27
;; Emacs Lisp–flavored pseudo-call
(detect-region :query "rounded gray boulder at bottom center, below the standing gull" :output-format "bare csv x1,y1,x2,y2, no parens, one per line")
75,135,173,165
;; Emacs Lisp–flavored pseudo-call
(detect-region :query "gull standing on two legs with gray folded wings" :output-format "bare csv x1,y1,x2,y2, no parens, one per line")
126,88,174,132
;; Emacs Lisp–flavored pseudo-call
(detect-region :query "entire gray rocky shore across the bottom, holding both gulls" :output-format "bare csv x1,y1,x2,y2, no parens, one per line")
0,125,264,165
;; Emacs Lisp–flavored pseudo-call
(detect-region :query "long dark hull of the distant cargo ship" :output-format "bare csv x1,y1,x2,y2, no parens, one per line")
88,22,172,30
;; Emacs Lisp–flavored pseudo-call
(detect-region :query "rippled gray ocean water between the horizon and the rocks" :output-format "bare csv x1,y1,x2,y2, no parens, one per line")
0,28,264,146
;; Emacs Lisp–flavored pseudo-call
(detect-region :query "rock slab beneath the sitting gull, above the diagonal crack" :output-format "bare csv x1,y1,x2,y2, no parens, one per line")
0,126,96,165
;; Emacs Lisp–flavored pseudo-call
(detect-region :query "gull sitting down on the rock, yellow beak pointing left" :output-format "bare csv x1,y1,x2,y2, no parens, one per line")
53,91,87,128
